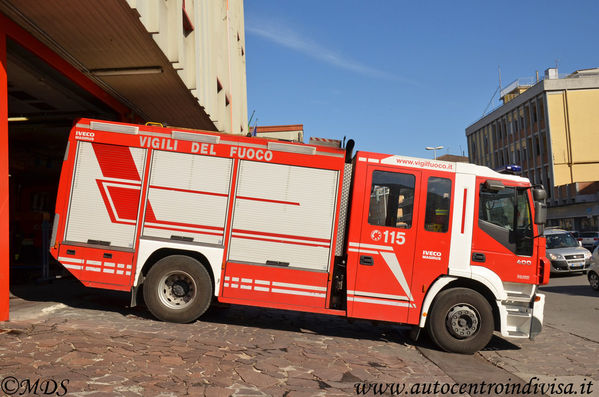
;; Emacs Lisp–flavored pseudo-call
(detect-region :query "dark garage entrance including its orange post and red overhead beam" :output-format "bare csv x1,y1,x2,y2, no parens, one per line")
0,21,127,321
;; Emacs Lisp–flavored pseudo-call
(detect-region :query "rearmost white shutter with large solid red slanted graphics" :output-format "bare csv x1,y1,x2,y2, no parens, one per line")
65,142,146,248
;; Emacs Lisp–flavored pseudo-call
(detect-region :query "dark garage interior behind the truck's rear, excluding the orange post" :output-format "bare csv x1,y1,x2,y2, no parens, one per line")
6,39,118,283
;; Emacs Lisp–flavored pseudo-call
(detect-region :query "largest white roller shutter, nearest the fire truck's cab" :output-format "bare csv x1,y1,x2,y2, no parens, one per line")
229,161,338,271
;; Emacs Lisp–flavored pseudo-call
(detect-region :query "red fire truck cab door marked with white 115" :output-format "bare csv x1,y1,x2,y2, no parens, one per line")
347,166,421,322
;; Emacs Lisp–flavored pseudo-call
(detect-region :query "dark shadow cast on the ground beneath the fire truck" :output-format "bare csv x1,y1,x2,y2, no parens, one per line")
10,277,524,354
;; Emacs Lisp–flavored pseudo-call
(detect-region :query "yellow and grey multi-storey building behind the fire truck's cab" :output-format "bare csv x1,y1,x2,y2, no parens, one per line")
466,68,599,230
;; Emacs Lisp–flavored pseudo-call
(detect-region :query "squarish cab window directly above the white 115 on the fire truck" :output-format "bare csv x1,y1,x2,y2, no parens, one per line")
368,171,416,229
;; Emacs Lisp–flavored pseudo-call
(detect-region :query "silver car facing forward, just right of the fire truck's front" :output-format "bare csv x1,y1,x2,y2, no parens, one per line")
545,229,592,273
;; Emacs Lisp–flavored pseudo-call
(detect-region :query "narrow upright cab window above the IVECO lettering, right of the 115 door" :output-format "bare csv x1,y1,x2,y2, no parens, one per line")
424,177,451,233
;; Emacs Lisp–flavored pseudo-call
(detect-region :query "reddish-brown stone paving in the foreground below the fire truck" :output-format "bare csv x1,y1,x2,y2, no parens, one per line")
0,278,452,396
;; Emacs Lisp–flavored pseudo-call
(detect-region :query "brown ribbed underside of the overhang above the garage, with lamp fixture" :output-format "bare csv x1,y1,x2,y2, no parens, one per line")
0,0,216,130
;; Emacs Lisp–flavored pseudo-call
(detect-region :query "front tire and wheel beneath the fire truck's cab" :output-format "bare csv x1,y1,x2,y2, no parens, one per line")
426,288,494,354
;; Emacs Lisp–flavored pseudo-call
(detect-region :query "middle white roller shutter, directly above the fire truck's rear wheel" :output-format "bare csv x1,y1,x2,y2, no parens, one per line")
143,151,232,245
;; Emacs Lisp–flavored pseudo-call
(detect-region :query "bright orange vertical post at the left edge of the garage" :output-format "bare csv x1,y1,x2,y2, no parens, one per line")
0,26,10,321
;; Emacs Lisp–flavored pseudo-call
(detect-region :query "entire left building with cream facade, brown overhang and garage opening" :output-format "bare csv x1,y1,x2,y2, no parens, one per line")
0,0,248,321
